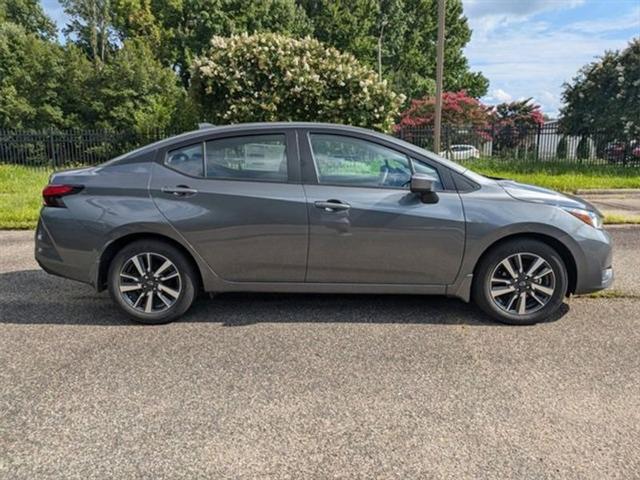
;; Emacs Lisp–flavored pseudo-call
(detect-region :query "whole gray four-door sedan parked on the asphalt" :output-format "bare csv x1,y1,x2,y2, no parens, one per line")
36,123,613,324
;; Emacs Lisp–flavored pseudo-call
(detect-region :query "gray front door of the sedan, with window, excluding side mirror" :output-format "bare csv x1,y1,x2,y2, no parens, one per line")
299,129,465,285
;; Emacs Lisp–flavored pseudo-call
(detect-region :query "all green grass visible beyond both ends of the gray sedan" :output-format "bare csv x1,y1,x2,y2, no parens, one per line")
0,159,640,229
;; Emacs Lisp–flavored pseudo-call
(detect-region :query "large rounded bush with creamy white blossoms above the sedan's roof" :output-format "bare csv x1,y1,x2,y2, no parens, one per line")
191,33,404,130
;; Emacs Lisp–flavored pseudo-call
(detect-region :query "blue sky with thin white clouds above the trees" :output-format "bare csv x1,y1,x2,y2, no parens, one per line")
42,0,640,117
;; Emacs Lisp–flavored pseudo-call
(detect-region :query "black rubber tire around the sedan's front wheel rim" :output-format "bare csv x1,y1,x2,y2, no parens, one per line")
471,239,568,325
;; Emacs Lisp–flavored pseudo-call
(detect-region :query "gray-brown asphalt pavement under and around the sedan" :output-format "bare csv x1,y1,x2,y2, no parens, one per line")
0,228,640,479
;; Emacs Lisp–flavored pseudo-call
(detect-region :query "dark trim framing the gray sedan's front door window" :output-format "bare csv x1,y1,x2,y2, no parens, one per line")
301,129,442,192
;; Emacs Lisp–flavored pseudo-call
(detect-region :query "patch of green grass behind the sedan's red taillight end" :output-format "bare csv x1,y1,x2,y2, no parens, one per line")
0,165,51,229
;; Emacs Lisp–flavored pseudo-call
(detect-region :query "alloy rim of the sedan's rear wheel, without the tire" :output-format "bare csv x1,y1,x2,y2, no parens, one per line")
118,252,182,314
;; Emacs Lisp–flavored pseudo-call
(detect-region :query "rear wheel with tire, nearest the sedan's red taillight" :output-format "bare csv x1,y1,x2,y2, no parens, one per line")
108,240,197,324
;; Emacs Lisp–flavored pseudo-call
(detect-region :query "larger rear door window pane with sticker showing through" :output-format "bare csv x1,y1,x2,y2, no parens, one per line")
205,135,287,182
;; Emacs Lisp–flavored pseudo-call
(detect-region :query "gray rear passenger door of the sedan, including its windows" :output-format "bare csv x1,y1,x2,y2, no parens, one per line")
150,129,308,282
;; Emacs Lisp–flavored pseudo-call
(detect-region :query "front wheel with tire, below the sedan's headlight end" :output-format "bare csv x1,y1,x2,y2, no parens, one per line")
473,239,568,325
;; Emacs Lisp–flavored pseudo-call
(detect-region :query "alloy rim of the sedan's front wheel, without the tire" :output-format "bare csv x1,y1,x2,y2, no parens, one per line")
490,252,556,315
